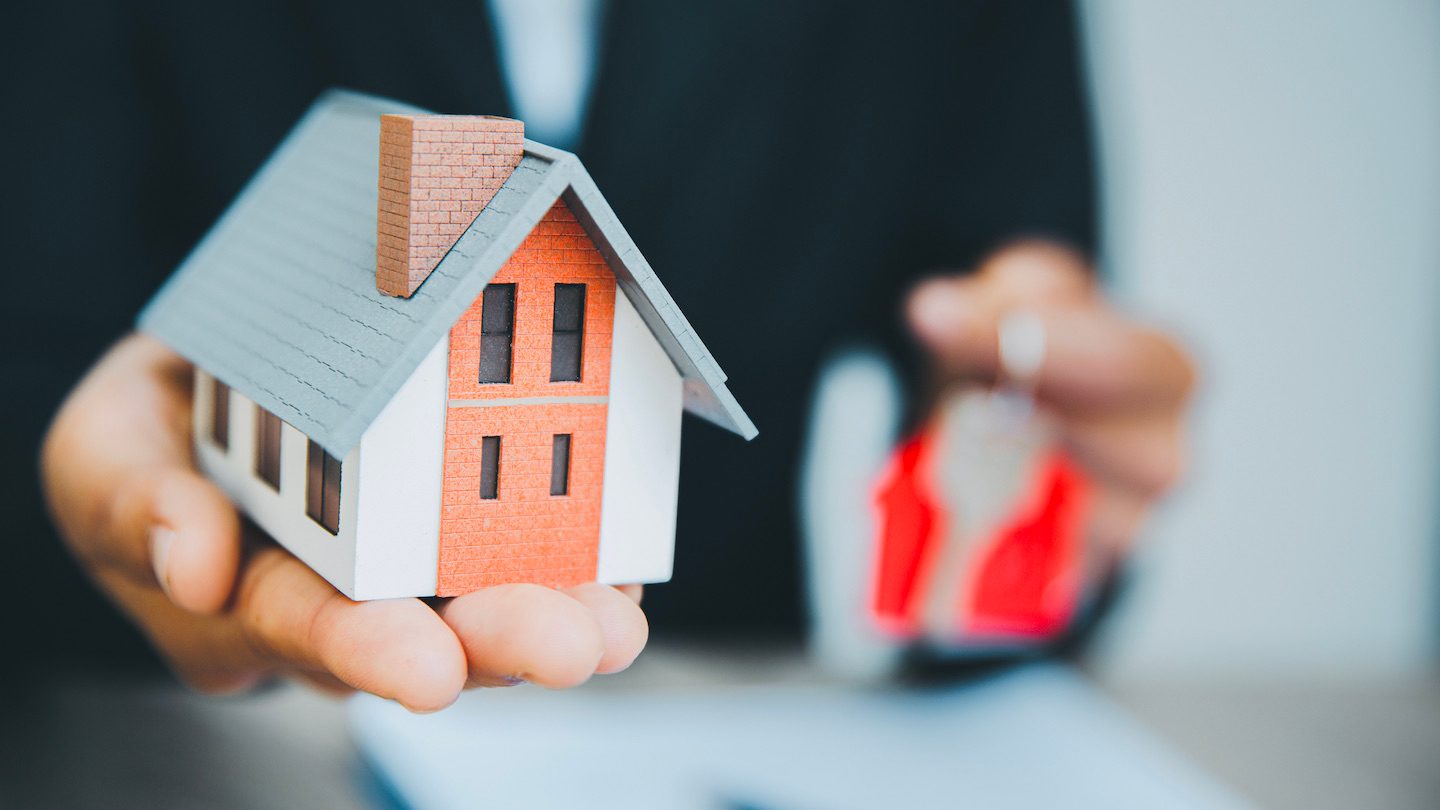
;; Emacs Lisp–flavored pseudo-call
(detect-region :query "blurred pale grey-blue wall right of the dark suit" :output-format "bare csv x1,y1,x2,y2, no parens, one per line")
1081,0,1440,675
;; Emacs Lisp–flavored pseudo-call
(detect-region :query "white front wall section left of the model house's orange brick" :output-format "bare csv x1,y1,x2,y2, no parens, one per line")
354,331,449,600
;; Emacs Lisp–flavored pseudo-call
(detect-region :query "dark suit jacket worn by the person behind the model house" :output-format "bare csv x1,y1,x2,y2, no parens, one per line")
0,0,1094,660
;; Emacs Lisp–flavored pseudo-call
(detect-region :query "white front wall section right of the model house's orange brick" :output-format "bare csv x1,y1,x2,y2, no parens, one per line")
596,295,684,585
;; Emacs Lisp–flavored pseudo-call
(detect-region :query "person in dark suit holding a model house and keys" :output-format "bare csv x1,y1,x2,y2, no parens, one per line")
0,0,1191,711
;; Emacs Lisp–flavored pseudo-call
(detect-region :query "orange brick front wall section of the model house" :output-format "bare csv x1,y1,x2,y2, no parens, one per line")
436,202,615,597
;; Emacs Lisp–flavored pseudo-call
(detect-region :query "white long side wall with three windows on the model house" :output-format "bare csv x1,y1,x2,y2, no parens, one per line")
192,370,360,598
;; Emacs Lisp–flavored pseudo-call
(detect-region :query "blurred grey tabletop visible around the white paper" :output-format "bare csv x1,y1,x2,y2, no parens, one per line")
0,649,1440,810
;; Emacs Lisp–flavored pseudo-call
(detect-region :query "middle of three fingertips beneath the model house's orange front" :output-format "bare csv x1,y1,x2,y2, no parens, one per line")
439,585,613,689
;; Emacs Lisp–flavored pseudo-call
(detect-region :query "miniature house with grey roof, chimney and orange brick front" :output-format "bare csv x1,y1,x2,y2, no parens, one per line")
140,92,756,600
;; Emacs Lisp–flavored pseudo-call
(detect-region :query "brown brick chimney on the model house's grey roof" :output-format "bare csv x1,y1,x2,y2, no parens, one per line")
374,115,526,298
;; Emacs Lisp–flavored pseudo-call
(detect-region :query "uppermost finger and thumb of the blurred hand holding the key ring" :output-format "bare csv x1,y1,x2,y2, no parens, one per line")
907,242,1194,412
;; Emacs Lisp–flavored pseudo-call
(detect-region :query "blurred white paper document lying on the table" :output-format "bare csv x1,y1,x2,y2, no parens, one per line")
351,664,1248,810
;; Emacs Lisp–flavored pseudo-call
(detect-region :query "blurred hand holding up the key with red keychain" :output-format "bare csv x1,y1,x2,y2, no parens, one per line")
907,242,1195,551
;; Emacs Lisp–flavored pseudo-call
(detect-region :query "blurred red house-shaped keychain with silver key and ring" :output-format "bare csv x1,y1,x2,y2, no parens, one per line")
871,313,1090,647
